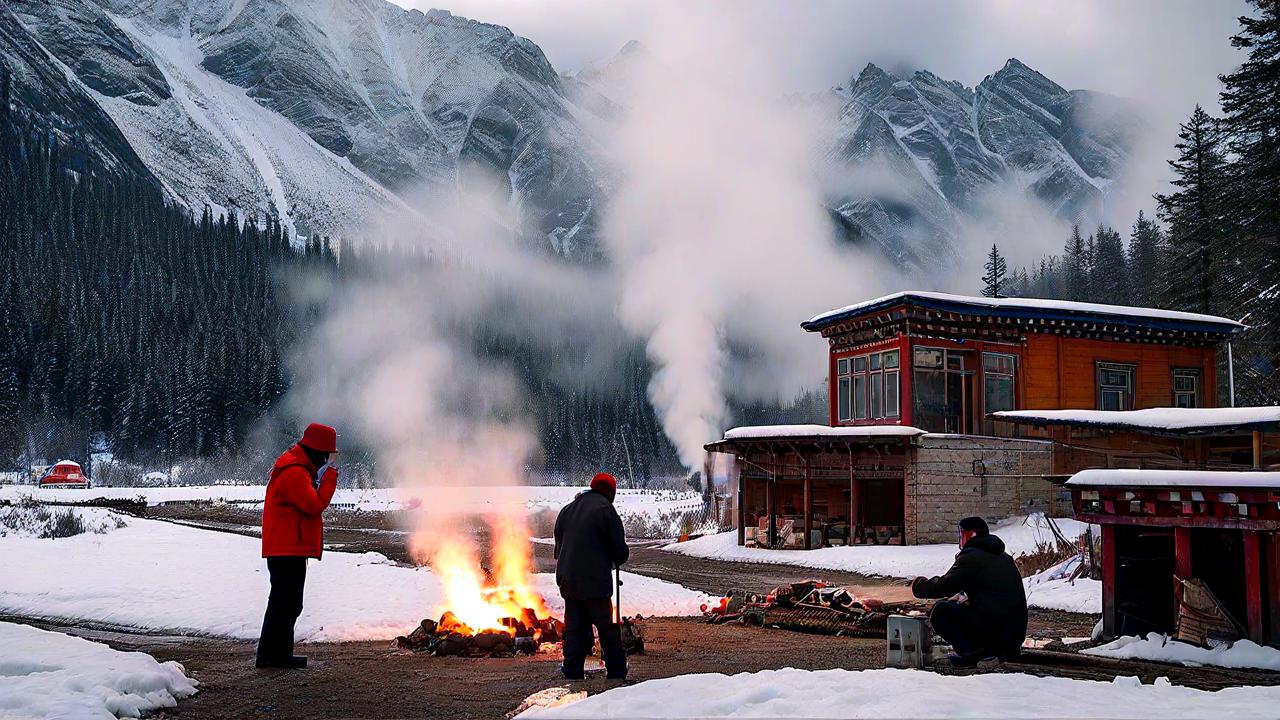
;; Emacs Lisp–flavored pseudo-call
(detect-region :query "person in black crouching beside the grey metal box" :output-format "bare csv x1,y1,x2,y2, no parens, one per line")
911,518,1027,667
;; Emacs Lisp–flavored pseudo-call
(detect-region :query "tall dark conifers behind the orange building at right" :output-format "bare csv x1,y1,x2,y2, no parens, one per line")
984,0,1280,405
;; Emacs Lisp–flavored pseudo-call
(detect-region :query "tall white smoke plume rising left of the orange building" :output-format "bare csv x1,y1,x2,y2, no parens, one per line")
603,11,896,469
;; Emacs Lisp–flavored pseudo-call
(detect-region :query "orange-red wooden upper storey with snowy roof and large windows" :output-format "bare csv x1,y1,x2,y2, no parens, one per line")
801,292,1243,434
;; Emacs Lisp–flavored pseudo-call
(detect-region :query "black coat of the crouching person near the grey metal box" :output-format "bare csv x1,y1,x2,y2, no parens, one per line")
911,536,1027,651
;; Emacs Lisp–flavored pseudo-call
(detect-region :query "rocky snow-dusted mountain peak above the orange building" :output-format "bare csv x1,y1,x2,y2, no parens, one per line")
828,59,1144,266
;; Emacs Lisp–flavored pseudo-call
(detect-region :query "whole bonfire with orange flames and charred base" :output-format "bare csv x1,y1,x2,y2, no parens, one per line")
396,516,562,657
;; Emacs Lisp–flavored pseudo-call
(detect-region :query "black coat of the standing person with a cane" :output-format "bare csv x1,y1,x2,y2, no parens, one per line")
556,489,631,600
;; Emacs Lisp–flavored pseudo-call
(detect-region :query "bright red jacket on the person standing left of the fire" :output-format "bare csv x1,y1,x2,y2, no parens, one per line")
262,445,338,557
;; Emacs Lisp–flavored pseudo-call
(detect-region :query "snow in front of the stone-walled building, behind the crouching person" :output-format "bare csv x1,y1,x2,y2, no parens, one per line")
663,515,1102,614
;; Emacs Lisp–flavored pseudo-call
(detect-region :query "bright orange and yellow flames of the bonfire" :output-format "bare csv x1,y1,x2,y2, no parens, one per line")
411,516,550,634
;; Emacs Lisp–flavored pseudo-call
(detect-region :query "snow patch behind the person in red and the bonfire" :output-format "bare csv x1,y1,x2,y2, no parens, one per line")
0,509,705,641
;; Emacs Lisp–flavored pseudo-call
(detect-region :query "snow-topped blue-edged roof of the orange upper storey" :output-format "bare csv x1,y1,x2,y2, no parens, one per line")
800,290,1244,333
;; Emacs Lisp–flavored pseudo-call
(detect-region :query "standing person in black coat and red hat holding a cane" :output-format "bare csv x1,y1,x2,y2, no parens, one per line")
556,473,630,680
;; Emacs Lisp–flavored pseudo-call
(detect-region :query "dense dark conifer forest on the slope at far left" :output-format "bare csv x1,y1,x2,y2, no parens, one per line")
0,78,335,470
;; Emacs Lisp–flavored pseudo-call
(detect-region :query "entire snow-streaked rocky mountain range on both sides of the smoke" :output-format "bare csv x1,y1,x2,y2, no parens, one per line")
0,0,1142,268
